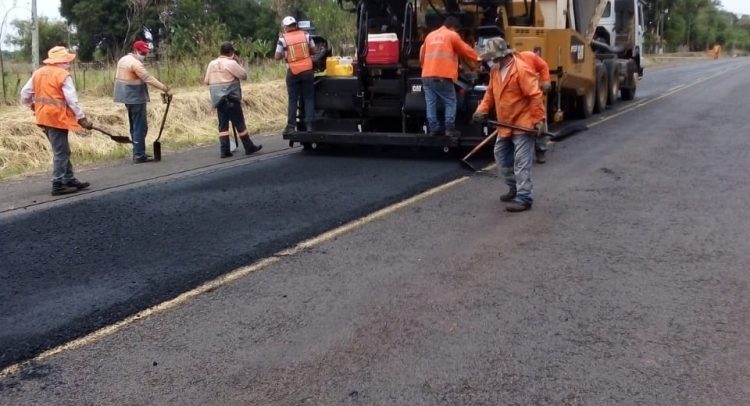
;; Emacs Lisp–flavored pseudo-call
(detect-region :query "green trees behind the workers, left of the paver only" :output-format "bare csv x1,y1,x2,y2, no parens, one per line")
6,0,355,62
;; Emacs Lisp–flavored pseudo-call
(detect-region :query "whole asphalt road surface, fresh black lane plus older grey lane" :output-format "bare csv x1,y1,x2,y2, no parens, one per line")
0,59,750,405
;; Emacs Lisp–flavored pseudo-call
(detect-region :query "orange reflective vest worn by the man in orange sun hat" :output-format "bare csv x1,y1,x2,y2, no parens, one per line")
31,65,81,130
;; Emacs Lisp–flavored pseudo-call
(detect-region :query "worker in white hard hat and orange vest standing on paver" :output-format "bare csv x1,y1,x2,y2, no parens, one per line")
274,16,315,135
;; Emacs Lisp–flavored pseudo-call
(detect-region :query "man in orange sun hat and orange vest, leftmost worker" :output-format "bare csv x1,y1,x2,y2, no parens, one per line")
21,46,93,196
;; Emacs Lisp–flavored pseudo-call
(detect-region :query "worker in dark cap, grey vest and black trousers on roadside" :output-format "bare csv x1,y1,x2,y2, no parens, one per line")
203,42,263,158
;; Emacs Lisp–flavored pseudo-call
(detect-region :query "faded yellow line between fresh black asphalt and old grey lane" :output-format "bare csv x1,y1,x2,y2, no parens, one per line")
0,176,469,379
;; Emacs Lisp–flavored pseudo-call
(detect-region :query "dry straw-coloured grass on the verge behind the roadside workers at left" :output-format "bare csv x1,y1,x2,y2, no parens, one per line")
0,80,287,179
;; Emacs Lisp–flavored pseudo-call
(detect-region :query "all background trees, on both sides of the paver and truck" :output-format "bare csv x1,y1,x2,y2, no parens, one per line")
2,0,750,61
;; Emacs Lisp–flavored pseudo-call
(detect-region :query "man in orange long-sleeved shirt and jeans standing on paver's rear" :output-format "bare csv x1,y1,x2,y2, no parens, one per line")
419,16,479,137
